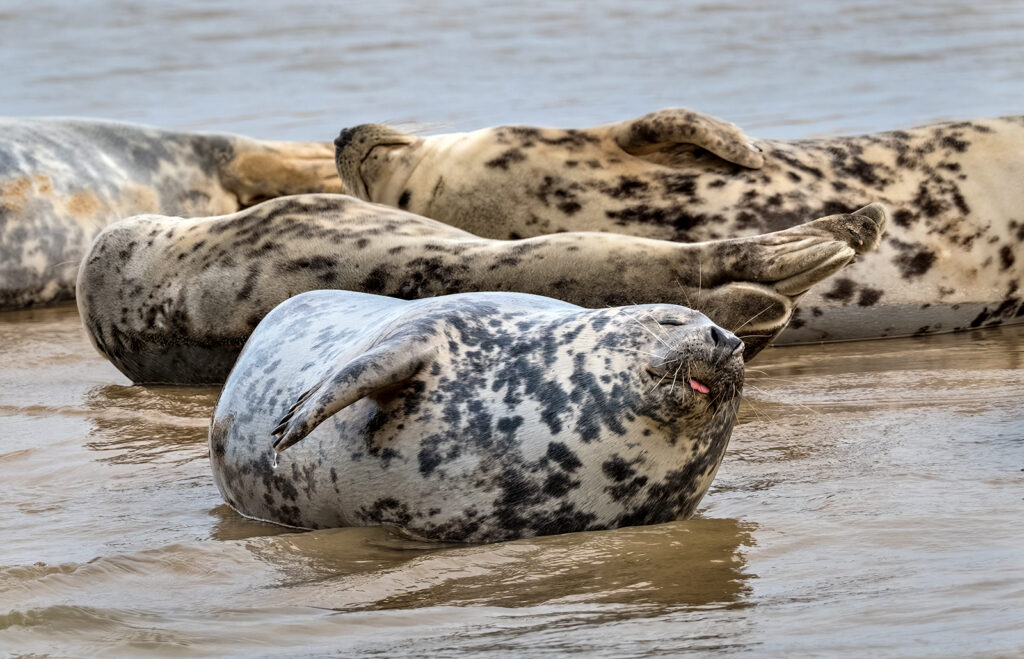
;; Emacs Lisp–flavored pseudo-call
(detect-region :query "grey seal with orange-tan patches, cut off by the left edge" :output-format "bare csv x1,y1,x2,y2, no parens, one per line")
0,118,343,309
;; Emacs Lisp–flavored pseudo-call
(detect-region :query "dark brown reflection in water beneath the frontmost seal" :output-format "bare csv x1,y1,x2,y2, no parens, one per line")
237,519,755,615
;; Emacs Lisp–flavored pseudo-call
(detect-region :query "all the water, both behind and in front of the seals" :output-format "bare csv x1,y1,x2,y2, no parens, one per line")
0,0,1024,657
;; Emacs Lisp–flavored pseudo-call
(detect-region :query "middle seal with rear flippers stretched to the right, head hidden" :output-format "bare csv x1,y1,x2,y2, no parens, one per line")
78,194,886,384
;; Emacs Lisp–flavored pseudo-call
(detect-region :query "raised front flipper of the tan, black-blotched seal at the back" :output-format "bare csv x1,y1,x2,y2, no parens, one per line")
609,107,765,169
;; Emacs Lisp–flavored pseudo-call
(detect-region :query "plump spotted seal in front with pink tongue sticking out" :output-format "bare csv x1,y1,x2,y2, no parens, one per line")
210,291,743,542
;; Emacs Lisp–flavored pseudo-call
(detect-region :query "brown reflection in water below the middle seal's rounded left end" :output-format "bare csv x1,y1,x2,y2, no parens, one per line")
83,385,219,464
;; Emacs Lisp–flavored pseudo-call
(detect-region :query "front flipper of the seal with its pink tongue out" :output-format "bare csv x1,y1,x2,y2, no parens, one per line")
270,340,437,453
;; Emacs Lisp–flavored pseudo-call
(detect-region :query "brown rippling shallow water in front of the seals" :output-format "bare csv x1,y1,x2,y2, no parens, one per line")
0,307,1024,657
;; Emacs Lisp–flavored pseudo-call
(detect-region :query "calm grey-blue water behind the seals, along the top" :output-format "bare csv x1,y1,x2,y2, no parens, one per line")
6,0,1024,140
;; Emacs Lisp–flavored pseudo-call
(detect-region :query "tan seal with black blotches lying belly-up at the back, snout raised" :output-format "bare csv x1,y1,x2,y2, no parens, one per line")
336,109,1024,343
